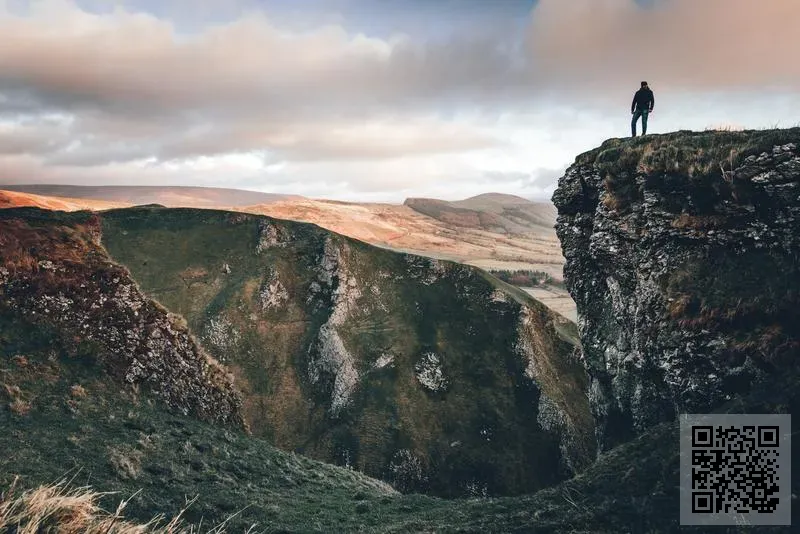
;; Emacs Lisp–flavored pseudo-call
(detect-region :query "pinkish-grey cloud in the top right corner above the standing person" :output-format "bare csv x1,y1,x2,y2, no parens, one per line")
528,0,800,94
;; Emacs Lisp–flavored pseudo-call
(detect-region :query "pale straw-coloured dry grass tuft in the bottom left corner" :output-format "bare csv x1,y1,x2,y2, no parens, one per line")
0,480,242,534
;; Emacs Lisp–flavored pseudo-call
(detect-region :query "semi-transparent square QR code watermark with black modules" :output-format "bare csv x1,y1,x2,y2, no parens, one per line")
680,414,792,525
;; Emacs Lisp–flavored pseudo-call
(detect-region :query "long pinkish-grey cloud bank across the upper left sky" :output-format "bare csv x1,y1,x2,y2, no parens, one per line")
0,2,526,120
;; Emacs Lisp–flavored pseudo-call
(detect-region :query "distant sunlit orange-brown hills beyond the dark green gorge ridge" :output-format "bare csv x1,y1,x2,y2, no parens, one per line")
0,189,575,319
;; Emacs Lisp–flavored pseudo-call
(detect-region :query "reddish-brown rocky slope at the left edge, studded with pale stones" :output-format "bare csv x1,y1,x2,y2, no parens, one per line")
0,210,244,427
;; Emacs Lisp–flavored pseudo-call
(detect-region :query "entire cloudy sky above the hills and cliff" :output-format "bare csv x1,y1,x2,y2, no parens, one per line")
0,0,800,202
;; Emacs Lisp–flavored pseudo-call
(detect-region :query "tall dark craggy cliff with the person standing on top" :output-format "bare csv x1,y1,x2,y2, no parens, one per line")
553,129,800,448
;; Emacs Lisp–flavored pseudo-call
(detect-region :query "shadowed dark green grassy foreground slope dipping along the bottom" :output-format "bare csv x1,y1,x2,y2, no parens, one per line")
0,315,800,534
